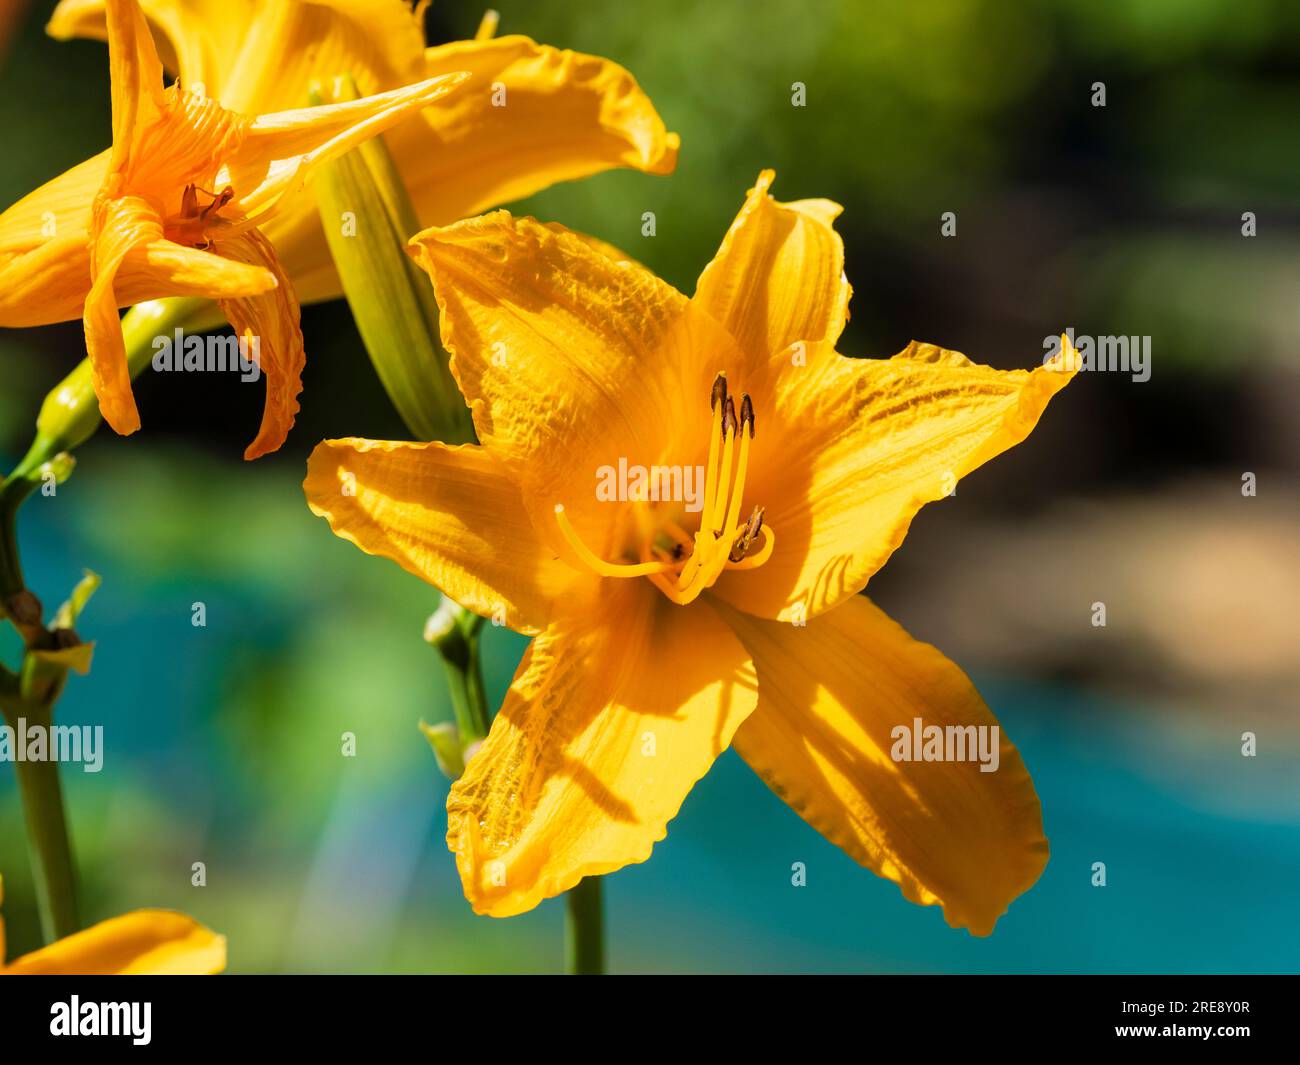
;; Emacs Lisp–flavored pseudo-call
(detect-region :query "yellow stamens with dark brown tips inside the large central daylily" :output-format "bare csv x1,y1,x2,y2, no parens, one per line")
555,373,776,606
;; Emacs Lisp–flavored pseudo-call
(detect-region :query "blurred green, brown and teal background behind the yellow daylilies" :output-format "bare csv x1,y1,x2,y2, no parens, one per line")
0,0,1300,971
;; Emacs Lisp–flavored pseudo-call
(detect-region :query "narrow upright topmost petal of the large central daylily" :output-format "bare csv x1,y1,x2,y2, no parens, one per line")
693,170,852,368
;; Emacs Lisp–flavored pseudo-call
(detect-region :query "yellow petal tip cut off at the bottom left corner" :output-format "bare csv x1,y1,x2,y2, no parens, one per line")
0,910,226,977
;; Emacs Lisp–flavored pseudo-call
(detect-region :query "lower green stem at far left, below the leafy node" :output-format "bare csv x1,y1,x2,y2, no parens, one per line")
7,703,81,943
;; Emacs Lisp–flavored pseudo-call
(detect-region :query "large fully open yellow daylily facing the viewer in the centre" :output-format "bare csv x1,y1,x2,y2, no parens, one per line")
304,172,1073,935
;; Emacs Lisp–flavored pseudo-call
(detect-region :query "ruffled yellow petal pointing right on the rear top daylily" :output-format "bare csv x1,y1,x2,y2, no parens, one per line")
389,35,679,225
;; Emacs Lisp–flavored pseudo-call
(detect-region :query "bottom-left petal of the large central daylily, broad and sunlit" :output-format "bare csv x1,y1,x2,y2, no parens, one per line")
447,581,755,917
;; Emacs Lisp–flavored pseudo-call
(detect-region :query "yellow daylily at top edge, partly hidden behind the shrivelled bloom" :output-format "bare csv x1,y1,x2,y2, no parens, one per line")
48,0,680,303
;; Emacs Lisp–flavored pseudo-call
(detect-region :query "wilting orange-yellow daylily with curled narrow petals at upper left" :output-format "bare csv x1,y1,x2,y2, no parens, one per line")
0,0,467,459
